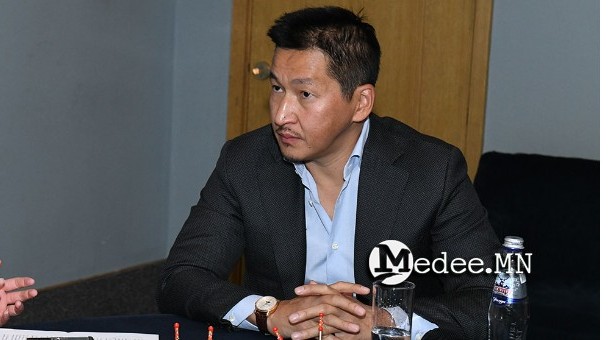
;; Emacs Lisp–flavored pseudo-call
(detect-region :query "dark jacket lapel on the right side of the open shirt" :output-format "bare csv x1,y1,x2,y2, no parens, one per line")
354,116,409,287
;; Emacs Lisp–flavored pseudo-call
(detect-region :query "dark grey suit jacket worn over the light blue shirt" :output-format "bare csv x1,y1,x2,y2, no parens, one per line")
159,115,499,339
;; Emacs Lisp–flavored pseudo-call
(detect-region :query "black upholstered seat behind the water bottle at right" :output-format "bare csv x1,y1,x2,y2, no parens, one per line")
474,152,600,339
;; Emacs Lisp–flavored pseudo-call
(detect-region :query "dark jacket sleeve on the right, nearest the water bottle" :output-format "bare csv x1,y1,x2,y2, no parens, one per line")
416,149,500,339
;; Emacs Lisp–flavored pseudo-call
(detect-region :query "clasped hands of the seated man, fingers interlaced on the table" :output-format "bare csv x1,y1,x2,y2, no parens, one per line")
268,282,372,340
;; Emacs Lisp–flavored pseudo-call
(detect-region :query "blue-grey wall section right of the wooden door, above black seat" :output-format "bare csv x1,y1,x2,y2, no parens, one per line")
484,0,600,160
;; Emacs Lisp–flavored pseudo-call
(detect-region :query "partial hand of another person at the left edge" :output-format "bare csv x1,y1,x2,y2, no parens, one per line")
0,261,38,326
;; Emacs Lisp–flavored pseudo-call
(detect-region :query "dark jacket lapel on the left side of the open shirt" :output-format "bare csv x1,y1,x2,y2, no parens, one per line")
259,137,306,296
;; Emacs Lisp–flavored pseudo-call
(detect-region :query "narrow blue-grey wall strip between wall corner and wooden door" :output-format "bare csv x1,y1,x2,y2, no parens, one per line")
167,0,232,250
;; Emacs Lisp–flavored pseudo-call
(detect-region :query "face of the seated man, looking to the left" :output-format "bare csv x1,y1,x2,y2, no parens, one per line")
269,48,360,164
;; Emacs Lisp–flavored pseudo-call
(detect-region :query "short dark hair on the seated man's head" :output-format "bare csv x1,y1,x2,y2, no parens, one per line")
267,7,381,99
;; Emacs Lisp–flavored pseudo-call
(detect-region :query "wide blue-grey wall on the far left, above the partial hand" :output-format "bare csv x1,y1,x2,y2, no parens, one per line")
0,0,174,287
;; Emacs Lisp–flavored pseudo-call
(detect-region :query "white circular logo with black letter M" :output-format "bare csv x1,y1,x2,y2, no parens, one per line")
369,240,413,285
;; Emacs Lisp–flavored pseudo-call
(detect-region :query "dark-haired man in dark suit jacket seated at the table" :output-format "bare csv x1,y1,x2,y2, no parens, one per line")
159,7,499,339
